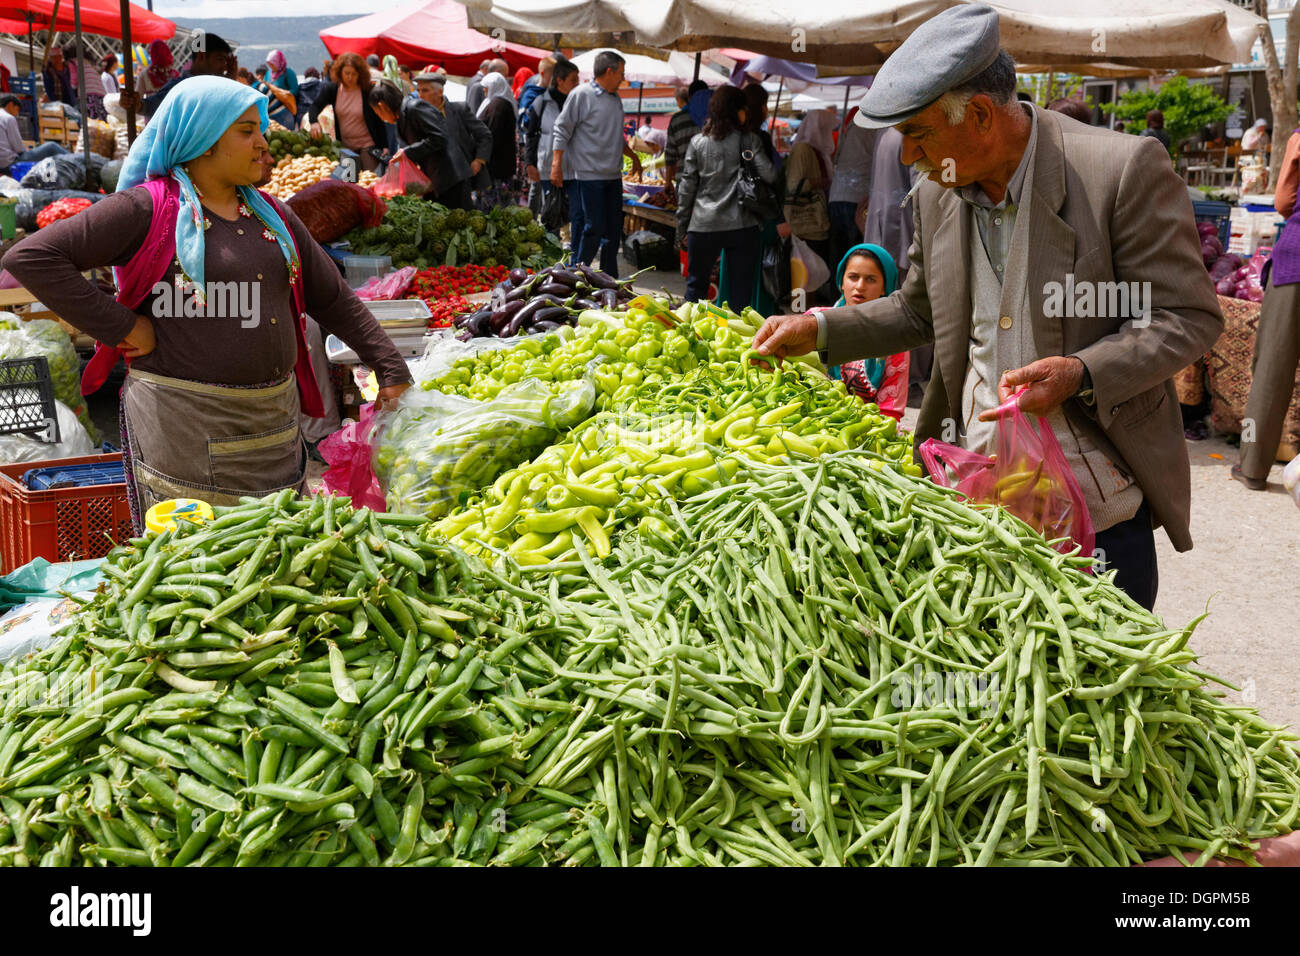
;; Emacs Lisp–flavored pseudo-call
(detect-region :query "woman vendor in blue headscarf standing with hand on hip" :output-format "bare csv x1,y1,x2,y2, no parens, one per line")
4,77,411,528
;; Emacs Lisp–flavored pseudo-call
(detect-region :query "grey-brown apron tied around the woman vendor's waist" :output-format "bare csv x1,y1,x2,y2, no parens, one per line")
122,369,307,515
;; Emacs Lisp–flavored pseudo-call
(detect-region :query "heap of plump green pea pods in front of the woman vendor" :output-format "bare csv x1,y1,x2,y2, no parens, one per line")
0,492,548,866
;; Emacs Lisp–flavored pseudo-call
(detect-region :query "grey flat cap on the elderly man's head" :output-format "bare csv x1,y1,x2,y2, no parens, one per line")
853,4,998,129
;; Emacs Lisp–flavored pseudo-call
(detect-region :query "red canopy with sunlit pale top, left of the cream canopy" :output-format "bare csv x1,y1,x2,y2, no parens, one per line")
325,0,549,77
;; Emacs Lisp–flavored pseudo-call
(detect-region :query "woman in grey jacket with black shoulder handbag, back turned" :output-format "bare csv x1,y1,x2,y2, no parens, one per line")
677,86,776,312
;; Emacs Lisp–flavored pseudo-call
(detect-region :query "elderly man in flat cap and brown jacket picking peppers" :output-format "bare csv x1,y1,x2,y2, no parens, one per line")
754,5,1223,609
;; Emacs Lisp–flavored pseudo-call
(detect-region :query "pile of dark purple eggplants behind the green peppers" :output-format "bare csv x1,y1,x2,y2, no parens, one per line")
455,264,640,342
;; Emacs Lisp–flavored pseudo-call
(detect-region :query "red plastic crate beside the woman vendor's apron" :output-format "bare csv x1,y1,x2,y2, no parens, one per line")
0,453,133,574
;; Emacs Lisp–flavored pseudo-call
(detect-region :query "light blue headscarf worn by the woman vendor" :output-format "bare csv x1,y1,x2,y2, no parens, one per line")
117,77,296,297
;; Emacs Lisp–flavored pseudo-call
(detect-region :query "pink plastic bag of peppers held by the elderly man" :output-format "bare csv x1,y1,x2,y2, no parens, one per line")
920,392,1096,554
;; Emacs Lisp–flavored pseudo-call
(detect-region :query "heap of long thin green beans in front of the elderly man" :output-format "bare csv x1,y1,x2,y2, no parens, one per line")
452,451,1300,866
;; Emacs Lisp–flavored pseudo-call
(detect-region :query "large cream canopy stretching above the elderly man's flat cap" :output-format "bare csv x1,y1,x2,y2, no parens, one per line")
464,0,1264,73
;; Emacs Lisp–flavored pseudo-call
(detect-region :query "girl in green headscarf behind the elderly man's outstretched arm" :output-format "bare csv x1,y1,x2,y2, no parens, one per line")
827,242,907,419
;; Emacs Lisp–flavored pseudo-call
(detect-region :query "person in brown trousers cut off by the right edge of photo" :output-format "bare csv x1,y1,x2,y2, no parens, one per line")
1232,125,1300,492
